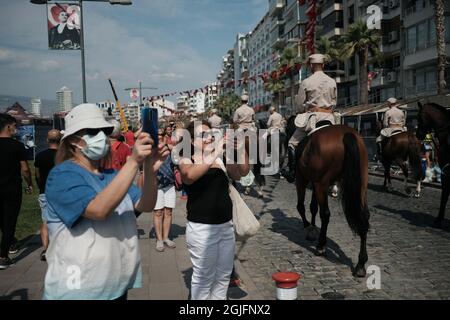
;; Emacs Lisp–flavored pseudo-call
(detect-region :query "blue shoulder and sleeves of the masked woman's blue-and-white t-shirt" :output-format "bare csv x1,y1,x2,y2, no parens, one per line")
45,161,141,229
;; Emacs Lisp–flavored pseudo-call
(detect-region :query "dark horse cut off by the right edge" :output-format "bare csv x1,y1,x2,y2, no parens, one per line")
417,102,450,229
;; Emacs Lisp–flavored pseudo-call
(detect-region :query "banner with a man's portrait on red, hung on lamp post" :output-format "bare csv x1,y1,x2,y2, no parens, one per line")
47,3,81,50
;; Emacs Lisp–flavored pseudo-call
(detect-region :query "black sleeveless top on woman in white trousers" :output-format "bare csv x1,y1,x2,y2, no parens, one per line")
183,168,233,224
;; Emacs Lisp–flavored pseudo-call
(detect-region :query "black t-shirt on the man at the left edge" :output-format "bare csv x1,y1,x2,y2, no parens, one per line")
0,138,27,188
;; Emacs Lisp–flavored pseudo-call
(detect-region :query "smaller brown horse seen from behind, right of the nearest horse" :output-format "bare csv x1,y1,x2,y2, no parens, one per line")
381,132,422,198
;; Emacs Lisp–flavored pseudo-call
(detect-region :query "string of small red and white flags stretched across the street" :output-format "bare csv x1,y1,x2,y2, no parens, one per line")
143,63,302,103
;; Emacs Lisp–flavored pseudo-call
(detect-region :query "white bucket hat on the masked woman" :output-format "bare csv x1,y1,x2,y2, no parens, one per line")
62,103,114,140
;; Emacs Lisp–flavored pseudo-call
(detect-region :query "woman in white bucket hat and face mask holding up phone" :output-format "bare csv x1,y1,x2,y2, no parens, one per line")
44,104,169,300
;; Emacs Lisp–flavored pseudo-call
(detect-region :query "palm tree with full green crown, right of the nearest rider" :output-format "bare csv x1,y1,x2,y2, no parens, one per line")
340,20,381,105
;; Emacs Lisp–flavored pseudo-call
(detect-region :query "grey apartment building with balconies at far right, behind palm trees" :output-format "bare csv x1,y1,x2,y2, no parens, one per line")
318,0,450,107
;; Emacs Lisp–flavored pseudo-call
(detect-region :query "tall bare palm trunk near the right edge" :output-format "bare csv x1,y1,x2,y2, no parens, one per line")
434,0,447,94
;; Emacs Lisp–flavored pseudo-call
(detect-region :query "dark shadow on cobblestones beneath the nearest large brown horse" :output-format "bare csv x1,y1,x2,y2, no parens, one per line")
270,209,359,271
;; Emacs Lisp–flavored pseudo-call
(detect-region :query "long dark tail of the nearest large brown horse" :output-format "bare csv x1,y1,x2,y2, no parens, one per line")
342,133,369,235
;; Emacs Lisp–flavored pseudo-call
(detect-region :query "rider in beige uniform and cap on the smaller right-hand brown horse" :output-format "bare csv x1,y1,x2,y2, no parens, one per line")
376,98,407,156
